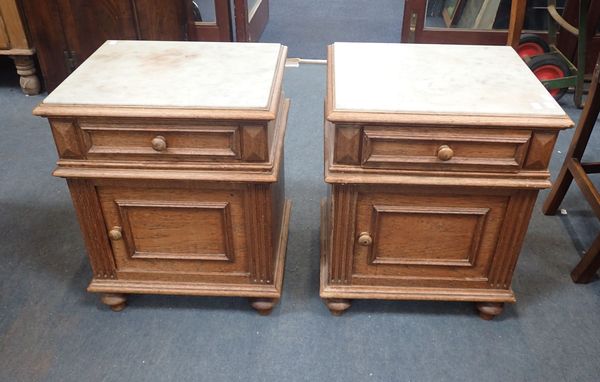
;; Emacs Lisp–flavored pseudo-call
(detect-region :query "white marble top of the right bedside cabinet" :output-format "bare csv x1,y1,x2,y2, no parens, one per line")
333,43,565,117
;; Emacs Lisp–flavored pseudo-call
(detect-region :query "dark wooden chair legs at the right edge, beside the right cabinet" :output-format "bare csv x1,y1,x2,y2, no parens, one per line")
543,56,600,283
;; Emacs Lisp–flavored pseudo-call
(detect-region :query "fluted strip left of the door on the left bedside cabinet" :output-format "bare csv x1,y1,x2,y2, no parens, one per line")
67,179,116,279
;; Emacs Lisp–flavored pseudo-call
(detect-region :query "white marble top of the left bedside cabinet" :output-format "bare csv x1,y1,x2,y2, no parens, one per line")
44,40,282,109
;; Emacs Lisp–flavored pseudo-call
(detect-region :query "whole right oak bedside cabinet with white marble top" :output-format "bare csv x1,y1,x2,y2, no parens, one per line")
321,43,572,319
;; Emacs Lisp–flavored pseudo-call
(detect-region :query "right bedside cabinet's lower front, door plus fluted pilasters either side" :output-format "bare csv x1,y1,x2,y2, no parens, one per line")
331,186,524,288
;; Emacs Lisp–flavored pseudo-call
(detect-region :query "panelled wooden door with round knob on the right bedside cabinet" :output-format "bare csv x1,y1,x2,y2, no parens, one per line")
352,187,510,287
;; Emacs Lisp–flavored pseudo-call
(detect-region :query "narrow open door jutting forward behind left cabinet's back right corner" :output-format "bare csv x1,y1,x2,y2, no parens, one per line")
234,0,269,42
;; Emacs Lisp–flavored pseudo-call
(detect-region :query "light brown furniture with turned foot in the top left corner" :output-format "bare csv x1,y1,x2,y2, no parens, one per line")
0,0,40,95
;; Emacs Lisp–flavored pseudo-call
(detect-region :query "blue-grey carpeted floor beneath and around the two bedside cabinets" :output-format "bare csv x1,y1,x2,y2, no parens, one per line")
0,0,600,382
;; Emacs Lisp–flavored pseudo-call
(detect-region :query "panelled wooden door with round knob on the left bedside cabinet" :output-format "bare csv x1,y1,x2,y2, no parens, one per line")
97,186,248,282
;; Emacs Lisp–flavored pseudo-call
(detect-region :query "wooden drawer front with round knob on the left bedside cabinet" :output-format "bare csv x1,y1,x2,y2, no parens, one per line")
80,123,240,161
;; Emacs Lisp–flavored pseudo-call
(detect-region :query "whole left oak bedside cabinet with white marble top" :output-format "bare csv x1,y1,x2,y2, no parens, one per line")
34,41,291,314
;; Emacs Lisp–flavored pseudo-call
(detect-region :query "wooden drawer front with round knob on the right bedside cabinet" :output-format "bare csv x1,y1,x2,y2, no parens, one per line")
361,127,531,171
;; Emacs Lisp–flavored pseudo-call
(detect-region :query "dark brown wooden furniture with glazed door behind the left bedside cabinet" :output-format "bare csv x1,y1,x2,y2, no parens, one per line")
20,0,269,91
